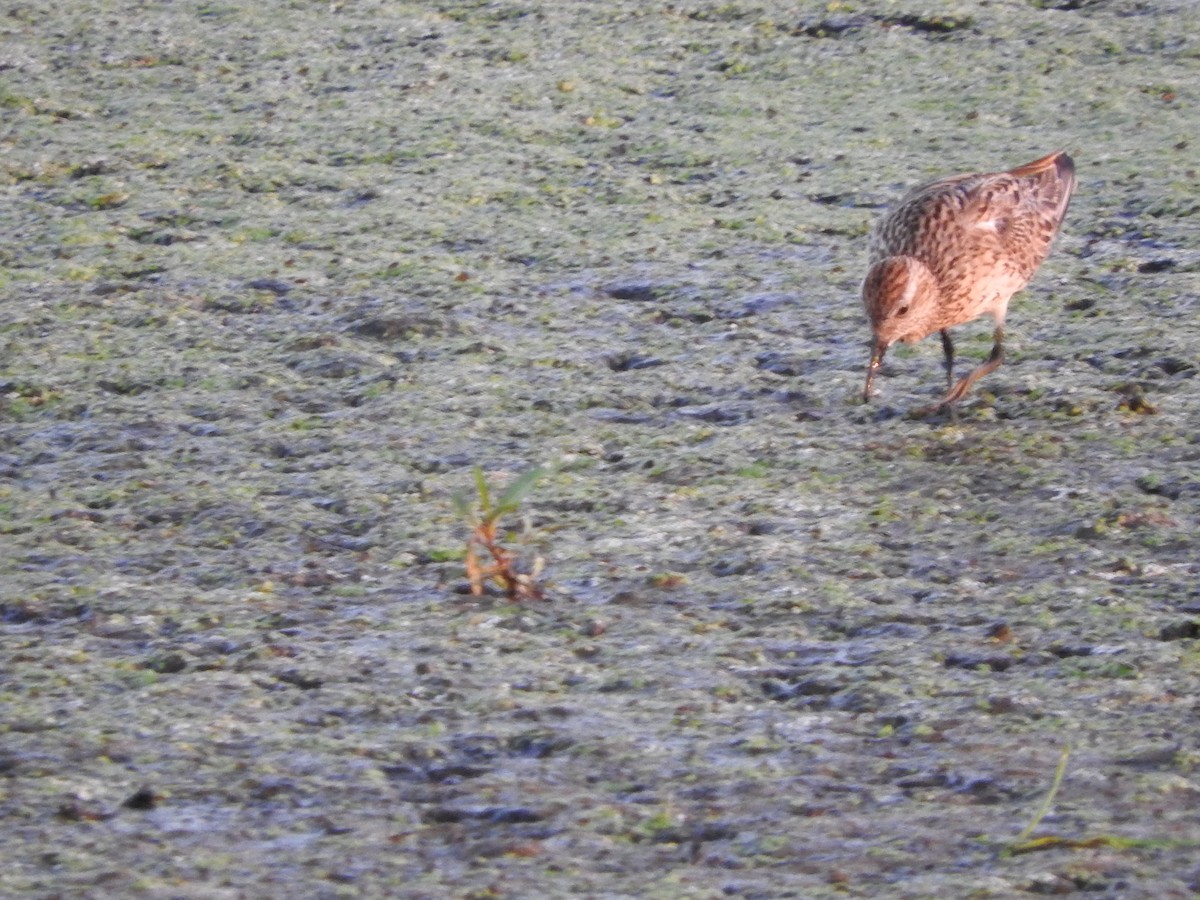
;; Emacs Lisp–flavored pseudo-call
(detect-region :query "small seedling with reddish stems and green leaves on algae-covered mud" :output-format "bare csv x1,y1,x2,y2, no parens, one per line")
455,466,544,600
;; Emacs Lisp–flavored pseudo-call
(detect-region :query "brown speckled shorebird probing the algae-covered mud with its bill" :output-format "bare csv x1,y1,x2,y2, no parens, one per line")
863,150,1075,414
